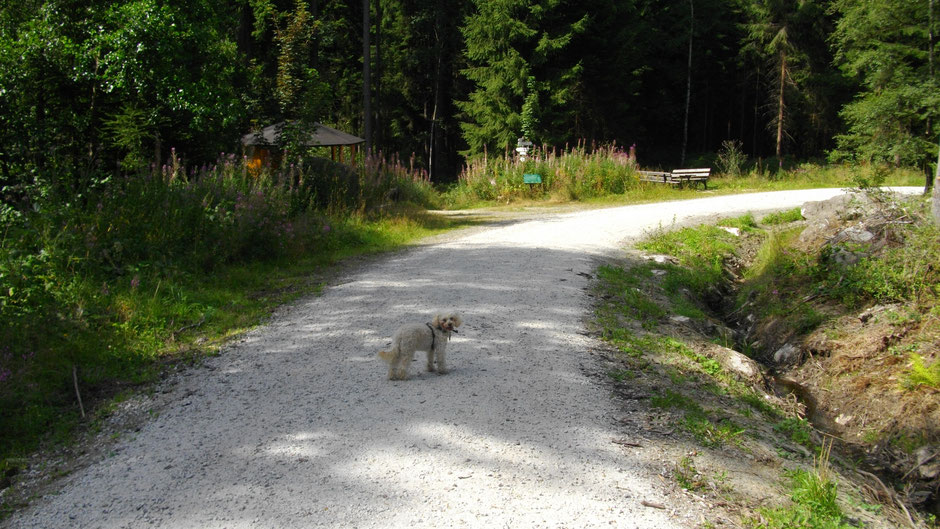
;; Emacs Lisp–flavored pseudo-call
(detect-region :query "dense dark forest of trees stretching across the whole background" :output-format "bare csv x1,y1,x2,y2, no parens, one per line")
0,0,940,194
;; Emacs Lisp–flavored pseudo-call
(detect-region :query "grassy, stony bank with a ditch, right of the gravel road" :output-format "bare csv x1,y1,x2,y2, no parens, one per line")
595,192,940,529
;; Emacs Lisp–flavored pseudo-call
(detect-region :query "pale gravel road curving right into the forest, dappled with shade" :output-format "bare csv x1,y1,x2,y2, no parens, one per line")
2,189,920,529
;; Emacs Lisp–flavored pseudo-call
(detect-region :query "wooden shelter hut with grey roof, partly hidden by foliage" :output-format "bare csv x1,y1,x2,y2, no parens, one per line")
242,122,366,168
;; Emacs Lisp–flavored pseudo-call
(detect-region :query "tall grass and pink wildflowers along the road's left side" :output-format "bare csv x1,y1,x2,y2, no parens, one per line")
0,153,434,458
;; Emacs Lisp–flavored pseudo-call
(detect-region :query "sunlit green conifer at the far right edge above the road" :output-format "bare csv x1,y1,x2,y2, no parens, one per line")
833,0,940,165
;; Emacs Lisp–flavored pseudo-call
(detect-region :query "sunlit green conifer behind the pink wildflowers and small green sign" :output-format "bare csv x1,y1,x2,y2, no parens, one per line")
458,0,589,155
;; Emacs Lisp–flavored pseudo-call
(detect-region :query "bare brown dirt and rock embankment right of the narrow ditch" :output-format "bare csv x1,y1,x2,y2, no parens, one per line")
729,194,940,516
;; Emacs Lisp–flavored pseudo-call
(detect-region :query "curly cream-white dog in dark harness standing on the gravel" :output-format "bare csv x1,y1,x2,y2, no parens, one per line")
379,313,463,380
